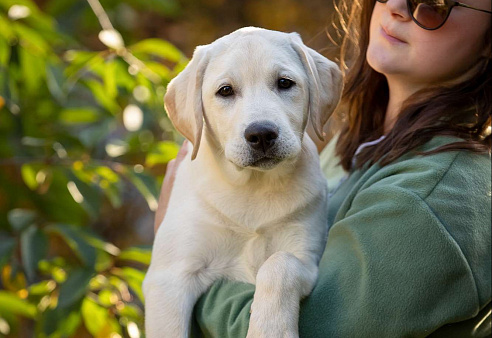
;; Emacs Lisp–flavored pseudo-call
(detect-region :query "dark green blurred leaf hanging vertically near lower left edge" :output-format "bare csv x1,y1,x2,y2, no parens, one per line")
21,225,48,282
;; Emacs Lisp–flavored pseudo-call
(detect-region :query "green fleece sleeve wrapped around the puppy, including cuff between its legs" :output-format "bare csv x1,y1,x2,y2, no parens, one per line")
192,184,484,337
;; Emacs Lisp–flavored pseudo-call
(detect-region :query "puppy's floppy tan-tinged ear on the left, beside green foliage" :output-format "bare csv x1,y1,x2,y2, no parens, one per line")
164,46,208,160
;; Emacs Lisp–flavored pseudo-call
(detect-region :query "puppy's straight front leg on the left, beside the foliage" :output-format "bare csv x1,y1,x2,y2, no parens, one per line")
143,269,209,338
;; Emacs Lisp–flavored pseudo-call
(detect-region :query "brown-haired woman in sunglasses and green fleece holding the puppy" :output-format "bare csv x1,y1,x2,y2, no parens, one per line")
156,0,492,337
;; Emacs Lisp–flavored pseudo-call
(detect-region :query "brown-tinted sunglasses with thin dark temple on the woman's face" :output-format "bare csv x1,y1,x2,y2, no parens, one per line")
377,0,492,30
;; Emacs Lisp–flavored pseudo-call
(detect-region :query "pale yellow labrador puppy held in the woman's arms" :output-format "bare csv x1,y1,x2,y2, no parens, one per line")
143,27,341,338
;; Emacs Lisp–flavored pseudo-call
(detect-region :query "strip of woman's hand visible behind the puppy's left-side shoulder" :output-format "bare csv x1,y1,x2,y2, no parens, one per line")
154,140,188,234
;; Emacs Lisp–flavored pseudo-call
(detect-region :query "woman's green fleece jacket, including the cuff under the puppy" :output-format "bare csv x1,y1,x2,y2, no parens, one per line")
190,137,491,338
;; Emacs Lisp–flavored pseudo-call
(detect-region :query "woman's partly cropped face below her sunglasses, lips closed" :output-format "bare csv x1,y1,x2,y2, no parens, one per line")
366,0,491,86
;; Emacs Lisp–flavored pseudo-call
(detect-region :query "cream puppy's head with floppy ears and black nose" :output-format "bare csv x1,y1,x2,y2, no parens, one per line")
165,28,342,170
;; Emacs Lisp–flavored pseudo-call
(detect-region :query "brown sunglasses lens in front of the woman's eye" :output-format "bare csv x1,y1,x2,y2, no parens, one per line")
408,0,451,29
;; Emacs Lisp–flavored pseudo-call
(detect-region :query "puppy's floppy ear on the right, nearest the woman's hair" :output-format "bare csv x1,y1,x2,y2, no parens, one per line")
291,33,343,141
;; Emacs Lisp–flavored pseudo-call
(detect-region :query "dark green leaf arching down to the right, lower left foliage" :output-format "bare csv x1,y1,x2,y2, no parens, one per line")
45,224,96,270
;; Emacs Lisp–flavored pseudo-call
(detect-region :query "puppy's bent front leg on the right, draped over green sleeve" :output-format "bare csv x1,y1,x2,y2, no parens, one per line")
247,251,318,338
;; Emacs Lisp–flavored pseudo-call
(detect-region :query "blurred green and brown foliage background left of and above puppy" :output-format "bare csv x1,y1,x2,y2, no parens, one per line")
0,0,337,338
